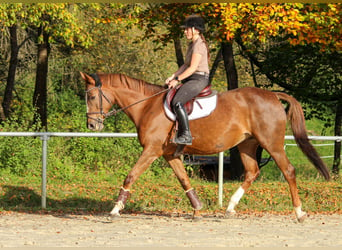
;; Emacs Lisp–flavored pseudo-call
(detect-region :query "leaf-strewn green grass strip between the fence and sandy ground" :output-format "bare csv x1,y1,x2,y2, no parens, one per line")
0,114,342,214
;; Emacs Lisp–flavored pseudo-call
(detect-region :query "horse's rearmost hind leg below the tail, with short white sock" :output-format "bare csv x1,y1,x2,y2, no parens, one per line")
267,143,306,222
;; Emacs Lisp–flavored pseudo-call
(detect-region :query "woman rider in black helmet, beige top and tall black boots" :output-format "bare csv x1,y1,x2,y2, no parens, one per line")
165,15,209,145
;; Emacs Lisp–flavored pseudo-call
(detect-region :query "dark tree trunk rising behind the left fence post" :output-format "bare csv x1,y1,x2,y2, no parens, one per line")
33,27,50,130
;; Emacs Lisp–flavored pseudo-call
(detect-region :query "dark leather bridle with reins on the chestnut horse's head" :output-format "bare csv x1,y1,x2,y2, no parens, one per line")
85,74,168,123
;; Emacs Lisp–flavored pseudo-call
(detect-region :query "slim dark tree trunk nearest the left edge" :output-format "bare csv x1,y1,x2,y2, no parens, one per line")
2,25,19,119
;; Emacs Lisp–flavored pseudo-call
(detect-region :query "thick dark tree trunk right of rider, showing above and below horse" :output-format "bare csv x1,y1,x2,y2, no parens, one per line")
221,42,244,179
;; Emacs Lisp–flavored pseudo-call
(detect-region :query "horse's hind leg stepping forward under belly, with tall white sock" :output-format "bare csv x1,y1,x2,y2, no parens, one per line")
226,138,260,215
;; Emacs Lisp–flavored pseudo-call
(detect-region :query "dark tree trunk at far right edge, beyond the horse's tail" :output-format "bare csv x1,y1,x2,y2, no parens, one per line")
332,100,342,176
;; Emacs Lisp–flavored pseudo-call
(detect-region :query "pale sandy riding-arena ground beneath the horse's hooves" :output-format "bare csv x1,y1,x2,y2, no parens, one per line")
0,212,342,247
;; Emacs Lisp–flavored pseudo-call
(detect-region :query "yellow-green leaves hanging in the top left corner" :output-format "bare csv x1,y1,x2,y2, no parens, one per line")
0,3,94,47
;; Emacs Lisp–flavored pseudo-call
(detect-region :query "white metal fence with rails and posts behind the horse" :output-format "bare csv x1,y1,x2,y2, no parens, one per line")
0,132,342,208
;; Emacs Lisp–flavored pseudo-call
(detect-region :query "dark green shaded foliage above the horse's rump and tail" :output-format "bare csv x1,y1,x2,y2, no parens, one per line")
261,43,342,127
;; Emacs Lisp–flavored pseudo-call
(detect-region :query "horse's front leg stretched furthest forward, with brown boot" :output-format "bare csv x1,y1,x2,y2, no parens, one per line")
110,150,159,216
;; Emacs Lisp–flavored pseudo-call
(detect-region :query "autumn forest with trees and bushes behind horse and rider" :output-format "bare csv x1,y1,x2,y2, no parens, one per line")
0,3,342,214
